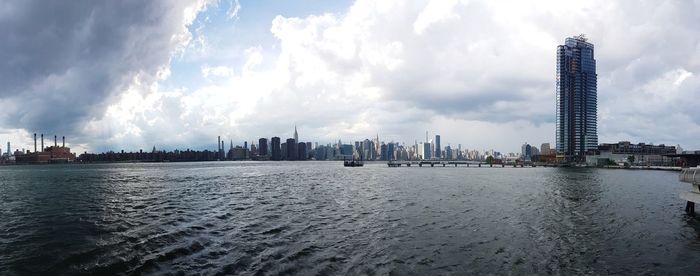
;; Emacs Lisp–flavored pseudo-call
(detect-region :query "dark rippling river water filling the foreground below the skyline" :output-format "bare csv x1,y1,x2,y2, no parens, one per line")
0,162,700,275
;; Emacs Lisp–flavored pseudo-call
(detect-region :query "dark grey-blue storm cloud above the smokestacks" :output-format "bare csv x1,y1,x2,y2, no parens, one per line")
0,1,202,137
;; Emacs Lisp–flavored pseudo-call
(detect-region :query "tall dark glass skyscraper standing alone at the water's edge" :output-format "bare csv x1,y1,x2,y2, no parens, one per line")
556,35,598,161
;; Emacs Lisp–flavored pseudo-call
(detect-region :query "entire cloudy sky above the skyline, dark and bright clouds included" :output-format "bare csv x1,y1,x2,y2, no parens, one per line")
0,0,700,152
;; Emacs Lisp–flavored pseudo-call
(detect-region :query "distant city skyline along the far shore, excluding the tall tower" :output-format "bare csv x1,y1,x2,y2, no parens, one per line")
0,123,684,166
